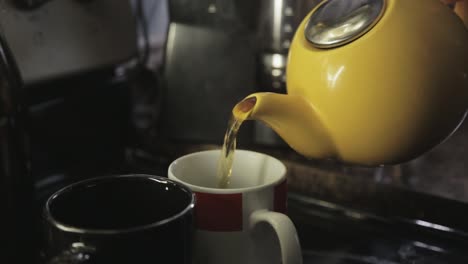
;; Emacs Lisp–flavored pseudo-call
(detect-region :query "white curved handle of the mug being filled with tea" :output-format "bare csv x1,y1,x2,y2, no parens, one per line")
249,210,302,264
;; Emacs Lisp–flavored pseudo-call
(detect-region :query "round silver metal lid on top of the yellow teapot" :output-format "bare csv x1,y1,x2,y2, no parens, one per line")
304,0,386,48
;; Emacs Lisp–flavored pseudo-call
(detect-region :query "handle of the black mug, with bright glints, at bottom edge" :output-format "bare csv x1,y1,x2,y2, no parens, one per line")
47,242,96,264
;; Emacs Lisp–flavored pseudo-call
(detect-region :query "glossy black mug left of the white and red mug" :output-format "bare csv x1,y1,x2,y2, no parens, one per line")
44,175,195,264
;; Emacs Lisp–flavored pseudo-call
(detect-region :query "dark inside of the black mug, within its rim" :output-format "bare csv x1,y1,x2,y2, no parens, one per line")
48,176,192,230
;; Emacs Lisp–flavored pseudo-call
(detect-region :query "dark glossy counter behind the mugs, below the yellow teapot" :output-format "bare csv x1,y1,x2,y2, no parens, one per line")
33,118,468,264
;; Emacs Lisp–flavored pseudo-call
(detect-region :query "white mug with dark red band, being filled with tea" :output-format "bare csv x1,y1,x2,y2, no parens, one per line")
168,150,302,264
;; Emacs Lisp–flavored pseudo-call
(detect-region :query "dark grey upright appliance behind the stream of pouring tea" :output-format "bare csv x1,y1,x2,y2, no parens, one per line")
162,0,258,144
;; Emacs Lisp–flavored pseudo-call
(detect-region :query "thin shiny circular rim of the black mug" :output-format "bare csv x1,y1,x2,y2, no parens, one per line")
44,174,195,234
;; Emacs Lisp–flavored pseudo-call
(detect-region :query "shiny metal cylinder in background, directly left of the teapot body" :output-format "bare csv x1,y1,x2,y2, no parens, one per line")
254,0,317,147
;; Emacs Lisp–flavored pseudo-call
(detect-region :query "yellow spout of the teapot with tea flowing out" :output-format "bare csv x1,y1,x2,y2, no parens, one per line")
233,93,337,159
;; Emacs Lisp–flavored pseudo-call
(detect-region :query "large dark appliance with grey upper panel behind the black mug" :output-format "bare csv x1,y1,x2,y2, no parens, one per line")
0,0,138,264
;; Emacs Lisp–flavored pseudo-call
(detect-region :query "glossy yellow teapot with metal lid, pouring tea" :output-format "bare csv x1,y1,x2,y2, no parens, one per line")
238,0,468,166
